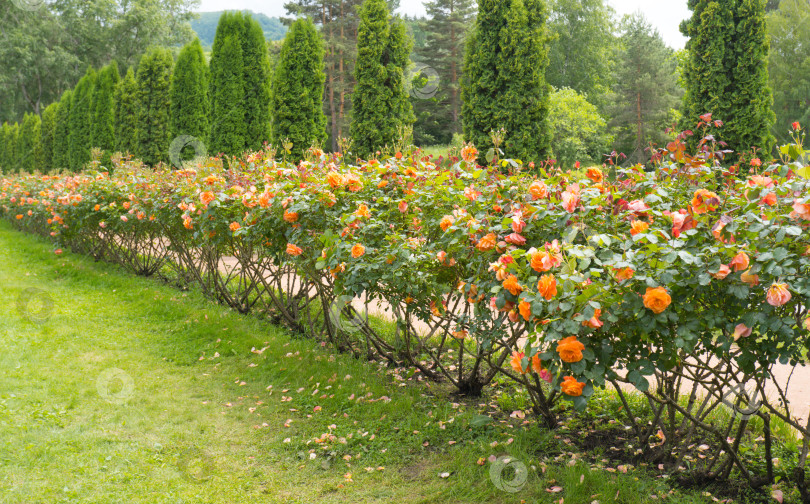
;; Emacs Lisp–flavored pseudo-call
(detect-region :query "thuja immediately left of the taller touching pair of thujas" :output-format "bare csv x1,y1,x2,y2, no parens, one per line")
170,39,211,158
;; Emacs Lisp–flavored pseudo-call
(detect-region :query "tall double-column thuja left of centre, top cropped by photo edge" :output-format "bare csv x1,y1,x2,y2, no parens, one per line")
351,0,413,157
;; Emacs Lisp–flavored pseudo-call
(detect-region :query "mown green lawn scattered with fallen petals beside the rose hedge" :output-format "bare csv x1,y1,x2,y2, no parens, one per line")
0,221,709,504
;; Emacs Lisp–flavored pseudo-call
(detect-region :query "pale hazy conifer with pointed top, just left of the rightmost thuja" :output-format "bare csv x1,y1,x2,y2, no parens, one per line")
611,14,682,163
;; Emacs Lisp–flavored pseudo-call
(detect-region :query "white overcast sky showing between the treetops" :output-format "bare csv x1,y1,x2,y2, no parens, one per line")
200,0,689,49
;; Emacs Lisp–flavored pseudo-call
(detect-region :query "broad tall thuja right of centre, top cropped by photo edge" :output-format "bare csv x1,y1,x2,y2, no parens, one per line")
461,0,551,162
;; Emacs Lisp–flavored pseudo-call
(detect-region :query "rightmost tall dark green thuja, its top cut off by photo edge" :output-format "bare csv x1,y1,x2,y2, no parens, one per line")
681,0,775,157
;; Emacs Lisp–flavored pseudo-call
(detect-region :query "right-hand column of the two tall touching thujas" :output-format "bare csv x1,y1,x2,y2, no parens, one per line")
241,14,272,151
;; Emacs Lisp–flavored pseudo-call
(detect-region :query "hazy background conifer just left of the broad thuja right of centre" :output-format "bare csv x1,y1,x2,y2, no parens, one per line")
411,0,475,144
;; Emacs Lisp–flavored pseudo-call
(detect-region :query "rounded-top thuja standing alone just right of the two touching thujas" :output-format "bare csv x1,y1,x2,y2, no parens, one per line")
271,19,326,153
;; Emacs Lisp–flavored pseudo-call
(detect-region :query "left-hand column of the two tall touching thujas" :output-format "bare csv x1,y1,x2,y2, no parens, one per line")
208,12,247,155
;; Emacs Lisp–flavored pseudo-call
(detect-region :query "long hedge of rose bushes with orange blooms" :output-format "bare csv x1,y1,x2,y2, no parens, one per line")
0,135,810,492
